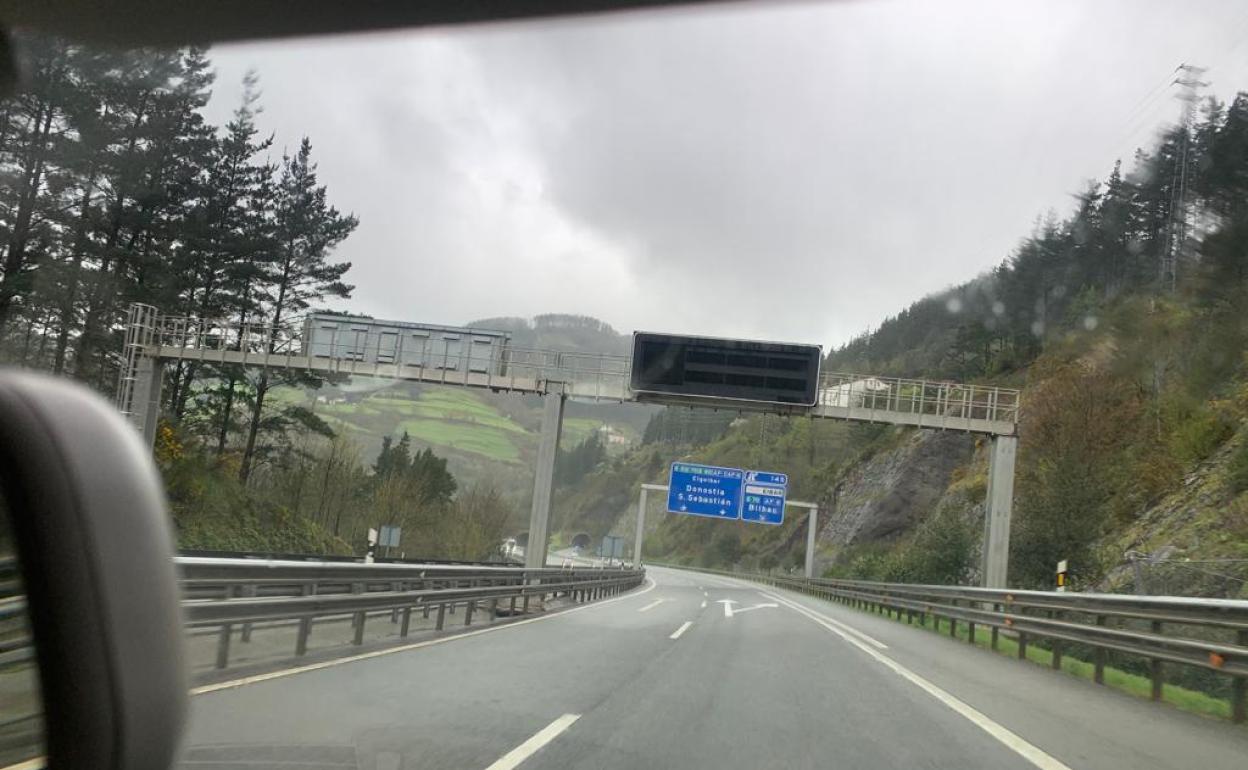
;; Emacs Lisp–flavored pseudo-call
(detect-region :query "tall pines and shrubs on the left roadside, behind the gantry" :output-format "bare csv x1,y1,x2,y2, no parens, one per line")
0,36,507,557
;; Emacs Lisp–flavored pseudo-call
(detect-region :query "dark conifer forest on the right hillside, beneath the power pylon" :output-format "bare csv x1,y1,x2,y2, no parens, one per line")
829,94,1248,378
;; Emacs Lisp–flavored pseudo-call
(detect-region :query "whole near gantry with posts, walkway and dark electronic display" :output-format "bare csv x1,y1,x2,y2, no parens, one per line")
117,303,1018,587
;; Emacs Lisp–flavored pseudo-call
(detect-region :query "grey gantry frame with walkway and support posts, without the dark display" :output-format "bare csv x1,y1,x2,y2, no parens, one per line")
117,305,1020,587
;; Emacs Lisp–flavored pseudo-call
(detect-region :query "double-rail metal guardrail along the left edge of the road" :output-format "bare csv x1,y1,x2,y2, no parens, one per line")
175,557,645,669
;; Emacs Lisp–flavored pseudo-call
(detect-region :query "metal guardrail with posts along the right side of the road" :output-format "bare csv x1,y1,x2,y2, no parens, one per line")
658,565,1248,723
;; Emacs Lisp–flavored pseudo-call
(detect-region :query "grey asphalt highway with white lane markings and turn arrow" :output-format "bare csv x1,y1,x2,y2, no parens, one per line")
182,568,1248,770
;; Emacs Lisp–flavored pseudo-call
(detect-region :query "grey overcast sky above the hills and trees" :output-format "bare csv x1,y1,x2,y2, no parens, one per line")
202,0,1248,347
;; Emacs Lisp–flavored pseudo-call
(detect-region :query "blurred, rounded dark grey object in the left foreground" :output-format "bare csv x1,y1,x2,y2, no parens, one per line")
0,369,187,770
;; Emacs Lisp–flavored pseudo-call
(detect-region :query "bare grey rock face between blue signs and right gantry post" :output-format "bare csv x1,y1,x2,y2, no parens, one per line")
819,431,975,550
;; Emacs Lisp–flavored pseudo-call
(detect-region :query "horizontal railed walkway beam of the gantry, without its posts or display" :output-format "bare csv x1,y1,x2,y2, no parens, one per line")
117,306,1018,436
